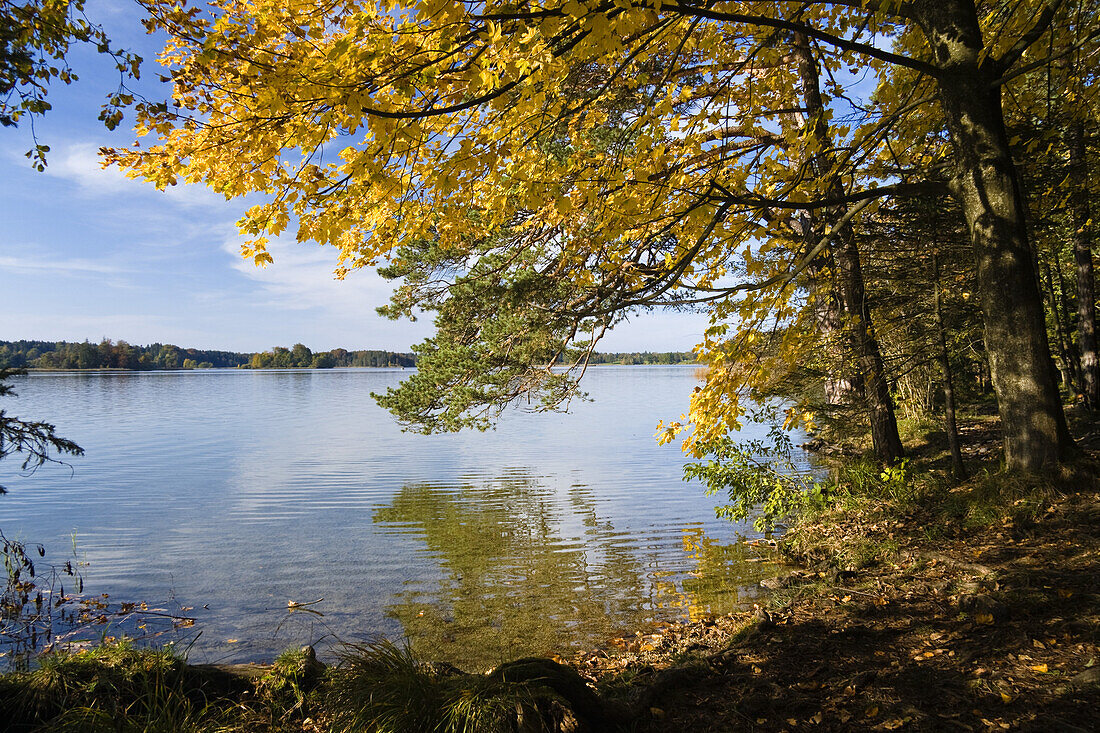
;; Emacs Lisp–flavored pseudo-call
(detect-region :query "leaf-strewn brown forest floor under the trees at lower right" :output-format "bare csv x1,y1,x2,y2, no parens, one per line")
572,411,1100,733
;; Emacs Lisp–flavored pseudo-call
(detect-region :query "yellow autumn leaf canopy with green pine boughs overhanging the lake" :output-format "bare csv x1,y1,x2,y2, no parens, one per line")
107,0,1080,455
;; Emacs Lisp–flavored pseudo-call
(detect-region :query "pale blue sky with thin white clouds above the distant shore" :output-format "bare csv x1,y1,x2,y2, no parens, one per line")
0,0,706,351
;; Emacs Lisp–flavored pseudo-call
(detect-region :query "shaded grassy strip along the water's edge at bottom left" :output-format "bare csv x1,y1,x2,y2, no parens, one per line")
0,641,629,733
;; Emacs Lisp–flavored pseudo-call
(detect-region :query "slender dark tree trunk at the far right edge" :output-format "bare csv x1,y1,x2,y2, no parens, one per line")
1068,122,1100,409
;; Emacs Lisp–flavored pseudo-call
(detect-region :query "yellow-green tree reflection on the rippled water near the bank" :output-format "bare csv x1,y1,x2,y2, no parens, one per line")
374,474,783,669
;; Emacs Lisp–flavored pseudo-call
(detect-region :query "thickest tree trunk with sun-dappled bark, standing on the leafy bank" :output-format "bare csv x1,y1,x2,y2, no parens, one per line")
913,0,1073,471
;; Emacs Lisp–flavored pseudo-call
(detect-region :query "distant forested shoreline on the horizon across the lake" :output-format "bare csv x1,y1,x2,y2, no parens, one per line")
0,339,694,371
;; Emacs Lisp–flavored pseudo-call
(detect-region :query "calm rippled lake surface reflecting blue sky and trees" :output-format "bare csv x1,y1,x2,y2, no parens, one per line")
0,367,805,664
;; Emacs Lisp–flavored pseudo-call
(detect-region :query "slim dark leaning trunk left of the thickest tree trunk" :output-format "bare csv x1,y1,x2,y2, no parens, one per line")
794,34,905,466
